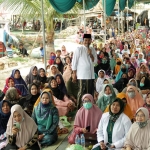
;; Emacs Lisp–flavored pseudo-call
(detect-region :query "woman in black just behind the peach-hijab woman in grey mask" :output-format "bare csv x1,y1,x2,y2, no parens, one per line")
113,73,128,92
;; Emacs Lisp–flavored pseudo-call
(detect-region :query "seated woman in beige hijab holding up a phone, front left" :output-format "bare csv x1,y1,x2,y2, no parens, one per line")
5,104,40,150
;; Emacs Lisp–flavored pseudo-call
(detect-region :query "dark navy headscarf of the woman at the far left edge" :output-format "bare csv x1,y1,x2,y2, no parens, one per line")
0,100,11,135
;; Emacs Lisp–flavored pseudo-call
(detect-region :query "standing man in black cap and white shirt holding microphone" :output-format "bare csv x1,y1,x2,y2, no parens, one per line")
72,34,97,108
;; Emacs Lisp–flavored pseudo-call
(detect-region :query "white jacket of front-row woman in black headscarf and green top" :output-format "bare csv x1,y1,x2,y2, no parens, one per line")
97,112,132,148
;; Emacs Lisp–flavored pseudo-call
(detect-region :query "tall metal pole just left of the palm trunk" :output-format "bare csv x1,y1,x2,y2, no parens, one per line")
41,0,47,70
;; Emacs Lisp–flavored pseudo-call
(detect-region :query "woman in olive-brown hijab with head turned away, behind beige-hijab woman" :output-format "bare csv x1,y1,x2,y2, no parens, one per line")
4,87,26,107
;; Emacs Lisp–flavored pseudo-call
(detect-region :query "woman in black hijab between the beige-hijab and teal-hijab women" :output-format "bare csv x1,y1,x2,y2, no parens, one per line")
24,83,40,116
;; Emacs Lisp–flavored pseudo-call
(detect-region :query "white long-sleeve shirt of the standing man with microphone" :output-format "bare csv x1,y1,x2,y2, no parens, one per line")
72,45,97,79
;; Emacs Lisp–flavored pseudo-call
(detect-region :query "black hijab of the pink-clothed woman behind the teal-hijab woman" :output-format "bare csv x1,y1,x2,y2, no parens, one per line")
48,77,64,100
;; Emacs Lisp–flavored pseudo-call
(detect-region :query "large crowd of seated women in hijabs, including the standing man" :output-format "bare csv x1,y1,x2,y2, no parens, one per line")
0,27,150,150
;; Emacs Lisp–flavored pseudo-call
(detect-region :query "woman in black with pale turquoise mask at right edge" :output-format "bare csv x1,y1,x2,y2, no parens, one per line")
138,76,150,96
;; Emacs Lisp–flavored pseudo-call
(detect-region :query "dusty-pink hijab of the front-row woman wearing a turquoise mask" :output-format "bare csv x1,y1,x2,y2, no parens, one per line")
74,94,102,133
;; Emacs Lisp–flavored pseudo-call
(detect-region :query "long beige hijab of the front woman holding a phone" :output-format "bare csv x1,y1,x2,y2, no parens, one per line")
6,104,37,148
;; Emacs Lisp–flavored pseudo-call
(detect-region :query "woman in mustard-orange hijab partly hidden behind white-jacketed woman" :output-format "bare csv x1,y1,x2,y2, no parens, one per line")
105,93,134,121
